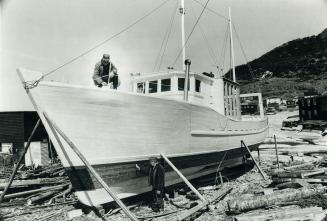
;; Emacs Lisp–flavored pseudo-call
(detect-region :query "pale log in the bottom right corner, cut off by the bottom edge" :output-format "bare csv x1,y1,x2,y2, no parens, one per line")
235,207,325,221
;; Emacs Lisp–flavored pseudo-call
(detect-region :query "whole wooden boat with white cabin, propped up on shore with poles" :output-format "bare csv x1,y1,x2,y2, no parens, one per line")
18,3,268,206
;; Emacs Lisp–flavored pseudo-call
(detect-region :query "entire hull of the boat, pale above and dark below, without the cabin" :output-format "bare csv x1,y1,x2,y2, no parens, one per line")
16,70,268,205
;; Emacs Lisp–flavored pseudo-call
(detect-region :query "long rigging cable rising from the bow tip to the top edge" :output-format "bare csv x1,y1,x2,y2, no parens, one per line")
42,0,170,78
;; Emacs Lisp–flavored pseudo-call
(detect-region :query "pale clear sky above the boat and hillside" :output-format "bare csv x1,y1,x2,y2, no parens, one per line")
0,0,327,111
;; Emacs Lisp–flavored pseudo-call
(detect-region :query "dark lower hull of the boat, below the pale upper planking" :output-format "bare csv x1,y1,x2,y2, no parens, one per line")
66,145,257,206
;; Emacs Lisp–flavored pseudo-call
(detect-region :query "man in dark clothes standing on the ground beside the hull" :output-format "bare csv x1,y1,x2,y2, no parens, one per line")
135,157,165,212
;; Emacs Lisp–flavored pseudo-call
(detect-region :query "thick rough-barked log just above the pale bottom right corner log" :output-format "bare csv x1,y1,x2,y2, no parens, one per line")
228,187,326,213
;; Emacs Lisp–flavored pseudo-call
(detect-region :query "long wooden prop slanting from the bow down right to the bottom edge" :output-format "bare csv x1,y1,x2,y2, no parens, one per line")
43,113,138,221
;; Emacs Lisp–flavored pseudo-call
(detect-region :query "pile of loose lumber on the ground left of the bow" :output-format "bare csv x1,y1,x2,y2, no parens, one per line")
0,164,72,205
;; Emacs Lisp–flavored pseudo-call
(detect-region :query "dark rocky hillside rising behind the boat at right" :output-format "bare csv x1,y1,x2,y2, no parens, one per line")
236,29,327,98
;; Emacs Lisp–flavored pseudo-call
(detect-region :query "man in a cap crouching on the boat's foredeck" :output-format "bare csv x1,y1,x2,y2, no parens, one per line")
92,54,120,89
